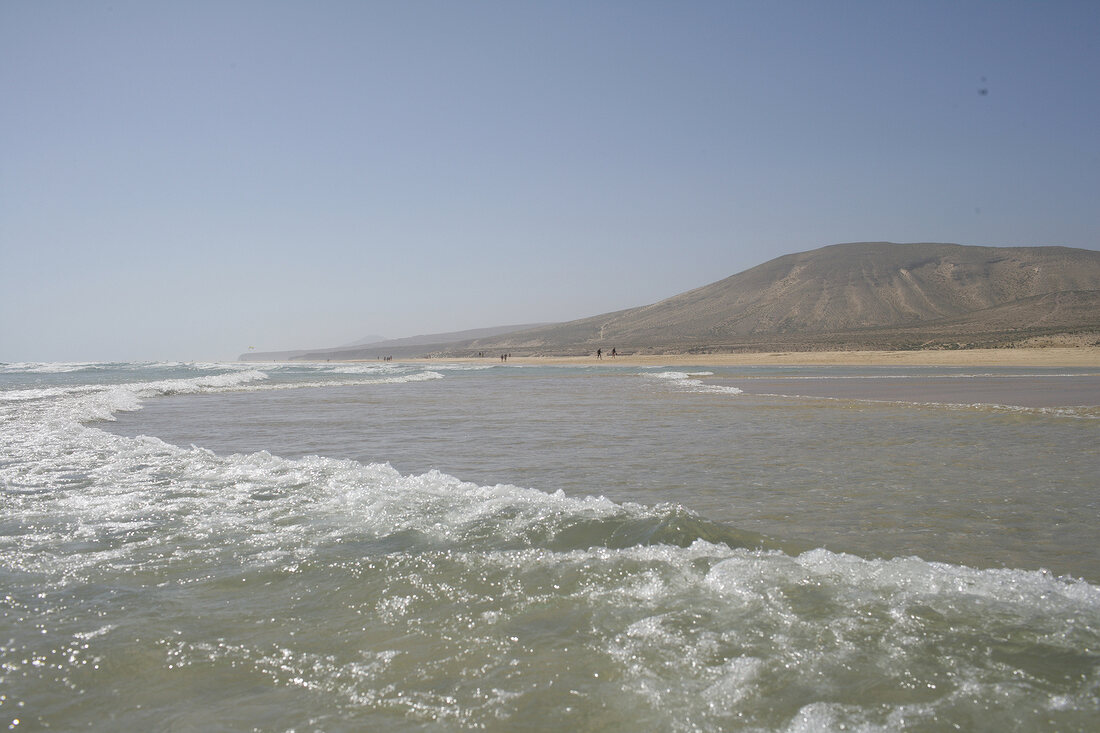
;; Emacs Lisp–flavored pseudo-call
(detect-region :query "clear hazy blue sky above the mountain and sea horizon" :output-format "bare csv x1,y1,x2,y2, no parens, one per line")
0,0,1100,362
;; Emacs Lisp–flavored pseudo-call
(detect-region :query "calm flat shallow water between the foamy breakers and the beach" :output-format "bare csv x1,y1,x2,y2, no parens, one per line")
105,368,1100,580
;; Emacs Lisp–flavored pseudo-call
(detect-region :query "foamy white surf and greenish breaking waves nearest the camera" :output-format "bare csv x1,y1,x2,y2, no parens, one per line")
0,367,1100,731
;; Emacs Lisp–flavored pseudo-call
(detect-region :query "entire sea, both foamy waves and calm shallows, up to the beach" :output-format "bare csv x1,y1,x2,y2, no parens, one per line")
0,360,1100,733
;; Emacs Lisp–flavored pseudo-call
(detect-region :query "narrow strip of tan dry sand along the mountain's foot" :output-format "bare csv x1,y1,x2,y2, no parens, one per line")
382,347,1100,369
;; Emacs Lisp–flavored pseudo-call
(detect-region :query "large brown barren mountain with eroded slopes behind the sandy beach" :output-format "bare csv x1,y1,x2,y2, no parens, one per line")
449,242,1100,355
